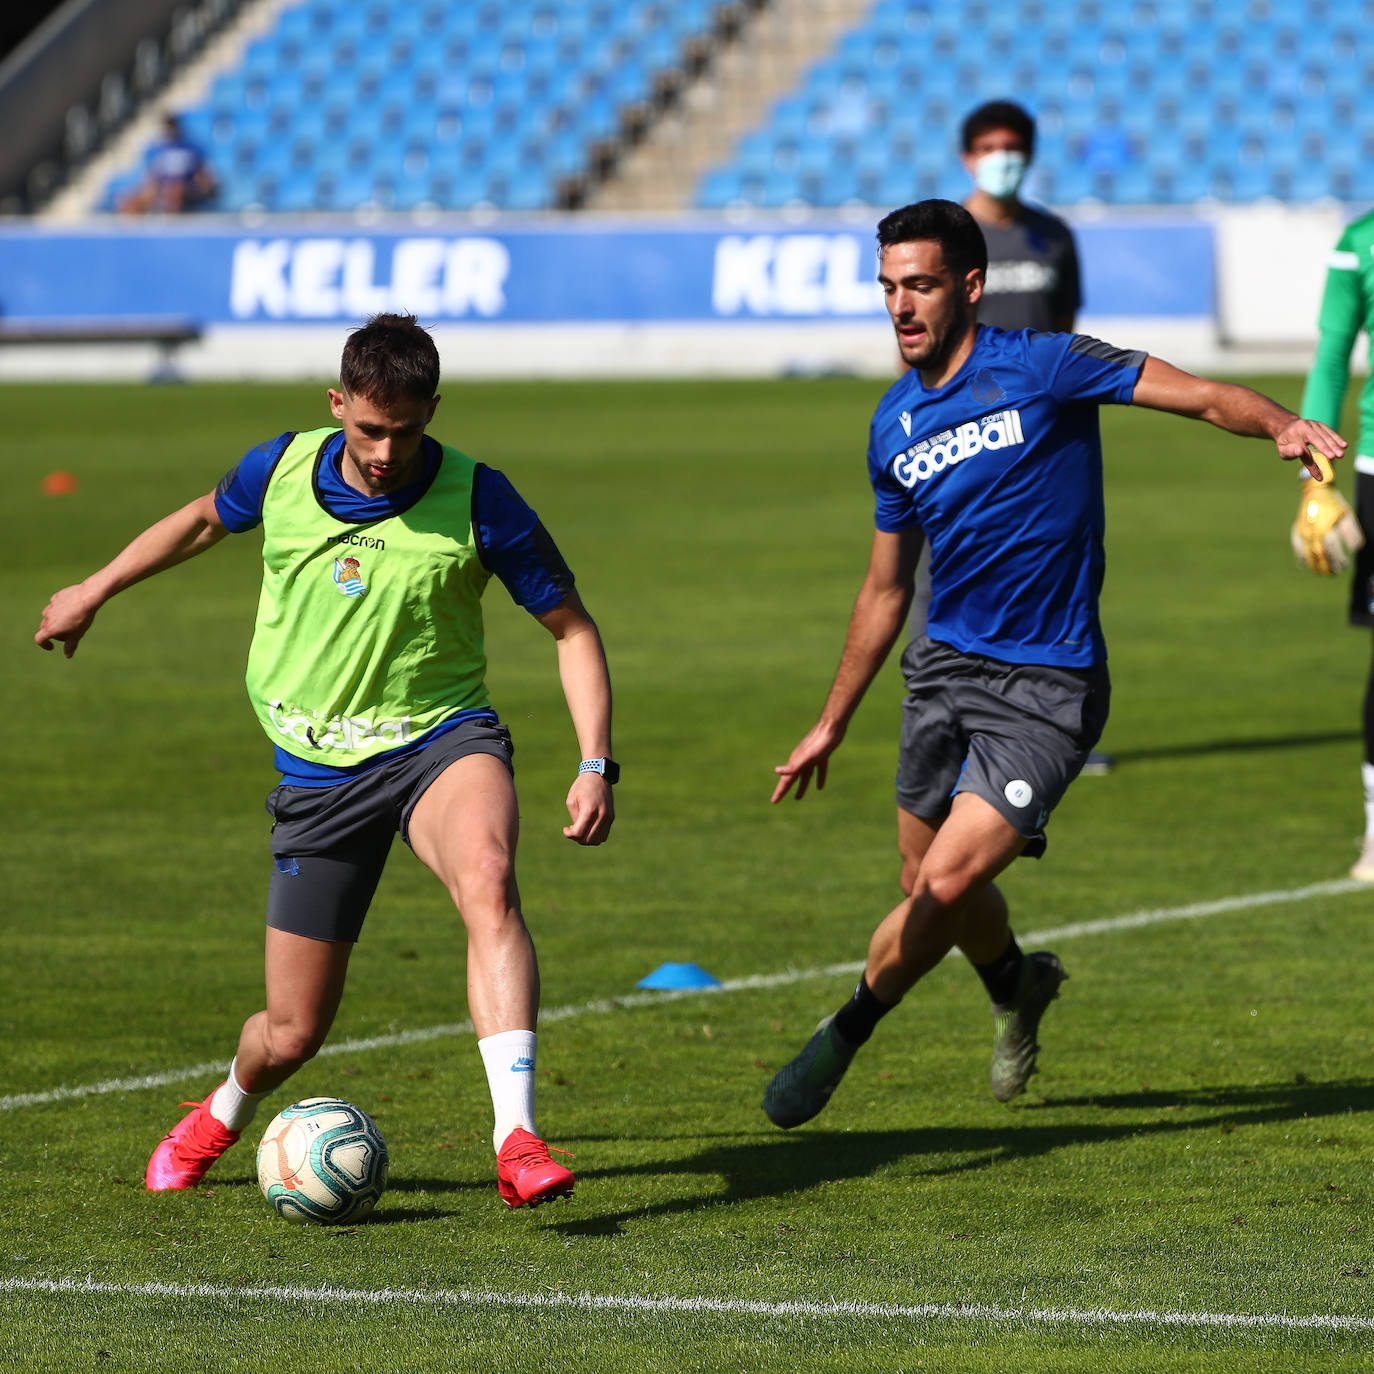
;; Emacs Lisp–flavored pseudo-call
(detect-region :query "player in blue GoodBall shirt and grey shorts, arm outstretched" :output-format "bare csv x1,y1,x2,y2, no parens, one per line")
763,201,1345,1128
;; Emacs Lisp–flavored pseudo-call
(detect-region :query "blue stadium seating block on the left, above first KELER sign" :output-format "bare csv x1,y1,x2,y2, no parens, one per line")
103,0,719,210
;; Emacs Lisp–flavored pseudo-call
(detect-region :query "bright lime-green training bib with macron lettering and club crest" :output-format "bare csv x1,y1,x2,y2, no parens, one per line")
247,429,489,768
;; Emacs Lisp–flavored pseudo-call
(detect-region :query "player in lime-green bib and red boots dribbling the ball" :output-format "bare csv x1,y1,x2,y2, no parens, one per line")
34,315,618,1208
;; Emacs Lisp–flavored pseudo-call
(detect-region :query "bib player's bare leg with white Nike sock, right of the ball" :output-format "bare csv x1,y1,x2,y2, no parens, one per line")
409,754,573,1206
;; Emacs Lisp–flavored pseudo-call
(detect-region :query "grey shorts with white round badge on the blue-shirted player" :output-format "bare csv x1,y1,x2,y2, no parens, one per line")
897,636,1112,859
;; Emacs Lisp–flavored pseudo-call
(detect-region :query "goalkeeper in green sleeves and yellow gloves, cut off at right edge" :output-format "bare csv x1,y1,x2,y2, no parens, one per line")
1293,213,1374,882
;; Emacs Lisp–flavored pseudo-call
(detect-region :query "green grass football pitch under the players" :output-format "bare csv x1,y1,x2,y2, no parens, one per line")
0,378,1374,1371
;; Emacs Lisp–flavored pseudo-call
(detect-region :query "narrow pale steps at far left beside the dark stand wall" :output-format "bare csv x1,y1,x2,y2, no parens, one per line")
42,0,297,224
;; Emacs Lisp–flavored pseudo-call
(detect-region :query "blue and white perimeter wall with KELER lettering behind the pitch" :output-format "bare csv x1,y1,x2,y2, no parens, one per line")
0,207,1344,379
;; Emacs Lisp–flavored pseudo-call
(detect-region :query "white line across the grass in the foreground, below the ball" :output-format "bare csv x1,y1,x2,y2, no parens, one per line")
0,1279,1374,1331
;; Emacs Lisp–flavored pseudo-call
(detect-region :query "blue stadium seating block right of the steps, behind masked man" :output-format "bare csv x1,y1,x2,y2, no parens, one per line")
694,0,1374,209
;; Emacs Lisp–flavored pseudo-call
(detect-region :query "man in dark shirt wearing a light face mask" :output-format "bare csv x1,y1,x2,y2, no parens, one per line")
960,100,1081,334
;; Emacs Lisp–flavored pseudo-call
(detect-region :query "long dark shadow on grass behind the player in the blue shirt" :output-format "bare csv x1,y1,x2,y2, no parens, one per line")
551,1079,1374,1235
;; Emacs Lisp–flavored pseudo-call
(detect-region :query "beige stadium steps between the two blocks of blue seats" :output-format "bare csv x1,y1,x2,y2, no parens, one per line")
584,0,870,212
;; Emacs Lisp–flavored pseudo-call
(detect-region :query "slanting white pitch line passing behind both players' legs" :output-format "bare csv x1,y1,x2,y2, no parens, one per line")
8,878,1374,1112
